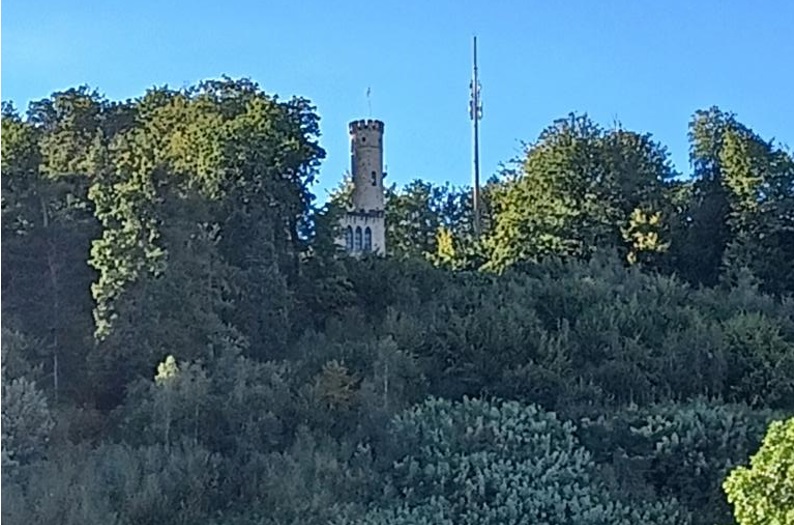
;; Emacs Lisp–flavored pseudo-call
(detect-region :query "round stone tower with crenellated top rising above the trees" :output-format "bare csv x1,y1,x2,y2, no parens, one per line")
339,120,386,255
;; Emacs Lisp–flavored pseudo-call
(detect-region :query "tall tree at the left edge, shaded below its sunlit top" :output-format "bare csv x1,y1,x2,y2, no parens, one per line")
2,96,104,401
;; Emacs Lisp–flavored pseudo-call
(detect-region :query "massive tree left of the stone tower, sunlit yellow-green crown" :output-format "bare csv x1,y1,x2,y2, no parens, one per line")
85,79,324,403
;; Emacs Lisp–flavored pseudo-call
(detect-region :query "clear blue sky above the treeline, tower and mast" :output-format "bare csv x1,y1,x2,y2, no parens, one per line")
2,0,794,199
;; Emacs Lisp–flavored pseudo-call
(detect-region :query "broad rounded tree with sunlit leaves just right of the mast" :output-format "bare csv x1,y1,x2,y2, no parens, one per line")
486,115,674,270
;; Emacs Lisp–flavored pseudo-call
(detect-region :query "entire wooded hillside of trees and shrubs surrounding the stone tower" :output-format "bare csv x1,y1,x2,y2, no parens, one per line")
2,78,794,525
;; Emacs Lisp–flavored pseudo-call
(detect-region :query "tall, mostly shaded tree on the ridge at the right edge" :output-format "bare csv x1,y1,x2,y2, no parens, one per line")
672,107,794,293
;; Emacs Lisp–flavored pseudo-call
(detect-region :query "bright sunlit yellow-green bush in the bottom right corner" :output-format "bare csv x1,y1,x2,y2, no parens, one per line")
724,418,794,525
